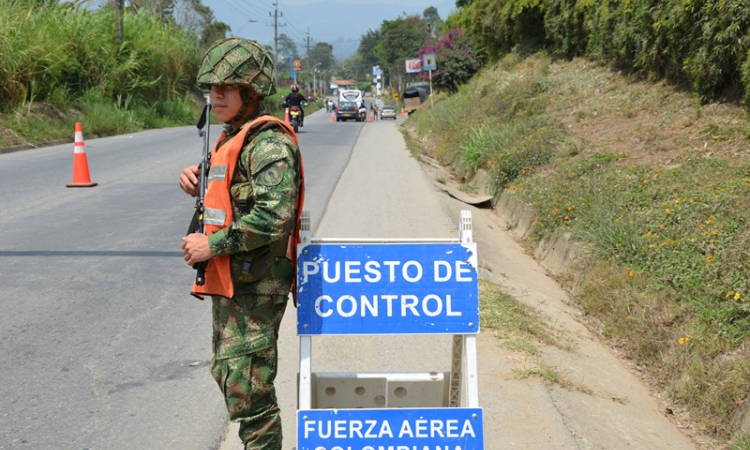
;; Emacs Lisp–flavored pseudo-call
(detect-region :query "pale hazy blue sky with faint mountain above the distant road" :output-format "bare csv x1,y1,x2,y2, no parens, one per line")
203,0,456,60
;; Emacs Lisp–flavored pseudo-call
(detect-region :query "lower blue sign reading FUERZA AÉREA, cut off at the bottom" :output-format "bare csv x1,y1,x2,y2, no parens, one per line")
297,408,484,450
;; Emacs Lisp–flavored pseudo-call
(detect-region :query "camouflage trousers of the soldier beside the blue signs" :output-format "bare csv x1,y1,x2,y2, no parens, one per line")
211,294,287,450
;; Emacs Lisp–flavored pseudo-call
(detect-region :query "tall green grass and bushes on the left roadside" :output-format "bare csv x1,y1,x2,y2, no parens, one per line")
0,0,322,148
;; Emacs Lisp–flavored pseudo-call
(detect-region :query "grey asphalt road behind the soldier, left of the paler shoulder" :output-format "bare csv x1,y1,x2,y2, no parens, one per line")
0,106,362,450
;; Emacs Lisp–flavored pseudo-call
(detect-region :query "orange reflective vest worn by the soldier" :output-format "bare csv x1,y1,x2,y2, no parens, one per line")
191,115,305,304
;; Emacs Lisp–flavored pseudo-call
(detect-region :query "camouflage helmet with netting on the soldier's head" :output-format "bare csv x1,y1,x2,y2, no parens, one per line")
198,37,276,97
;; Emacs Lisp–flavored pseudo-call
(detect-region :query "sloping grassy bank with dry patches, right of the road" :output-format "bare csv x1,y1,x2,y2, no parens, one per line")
407,54,750,450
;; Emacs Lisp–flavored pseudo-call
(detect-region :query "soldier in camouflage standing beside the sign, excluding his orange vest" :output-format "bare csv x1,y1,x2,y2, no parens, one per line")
180,38,302,450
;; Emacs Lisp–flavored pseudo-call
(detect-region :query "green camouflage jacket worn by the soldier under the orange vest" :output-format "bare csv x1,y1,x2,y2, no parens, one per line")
208,114,300,295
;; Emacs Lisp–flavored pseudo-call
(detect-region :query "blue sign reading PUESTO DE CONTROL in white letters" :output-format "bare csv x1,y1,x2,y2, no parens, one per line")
297,243,479,335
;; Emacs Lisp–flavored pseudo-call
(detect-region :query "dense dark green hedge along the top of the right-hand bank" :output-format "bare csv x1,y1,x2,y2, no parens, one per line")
447,0,750,102
